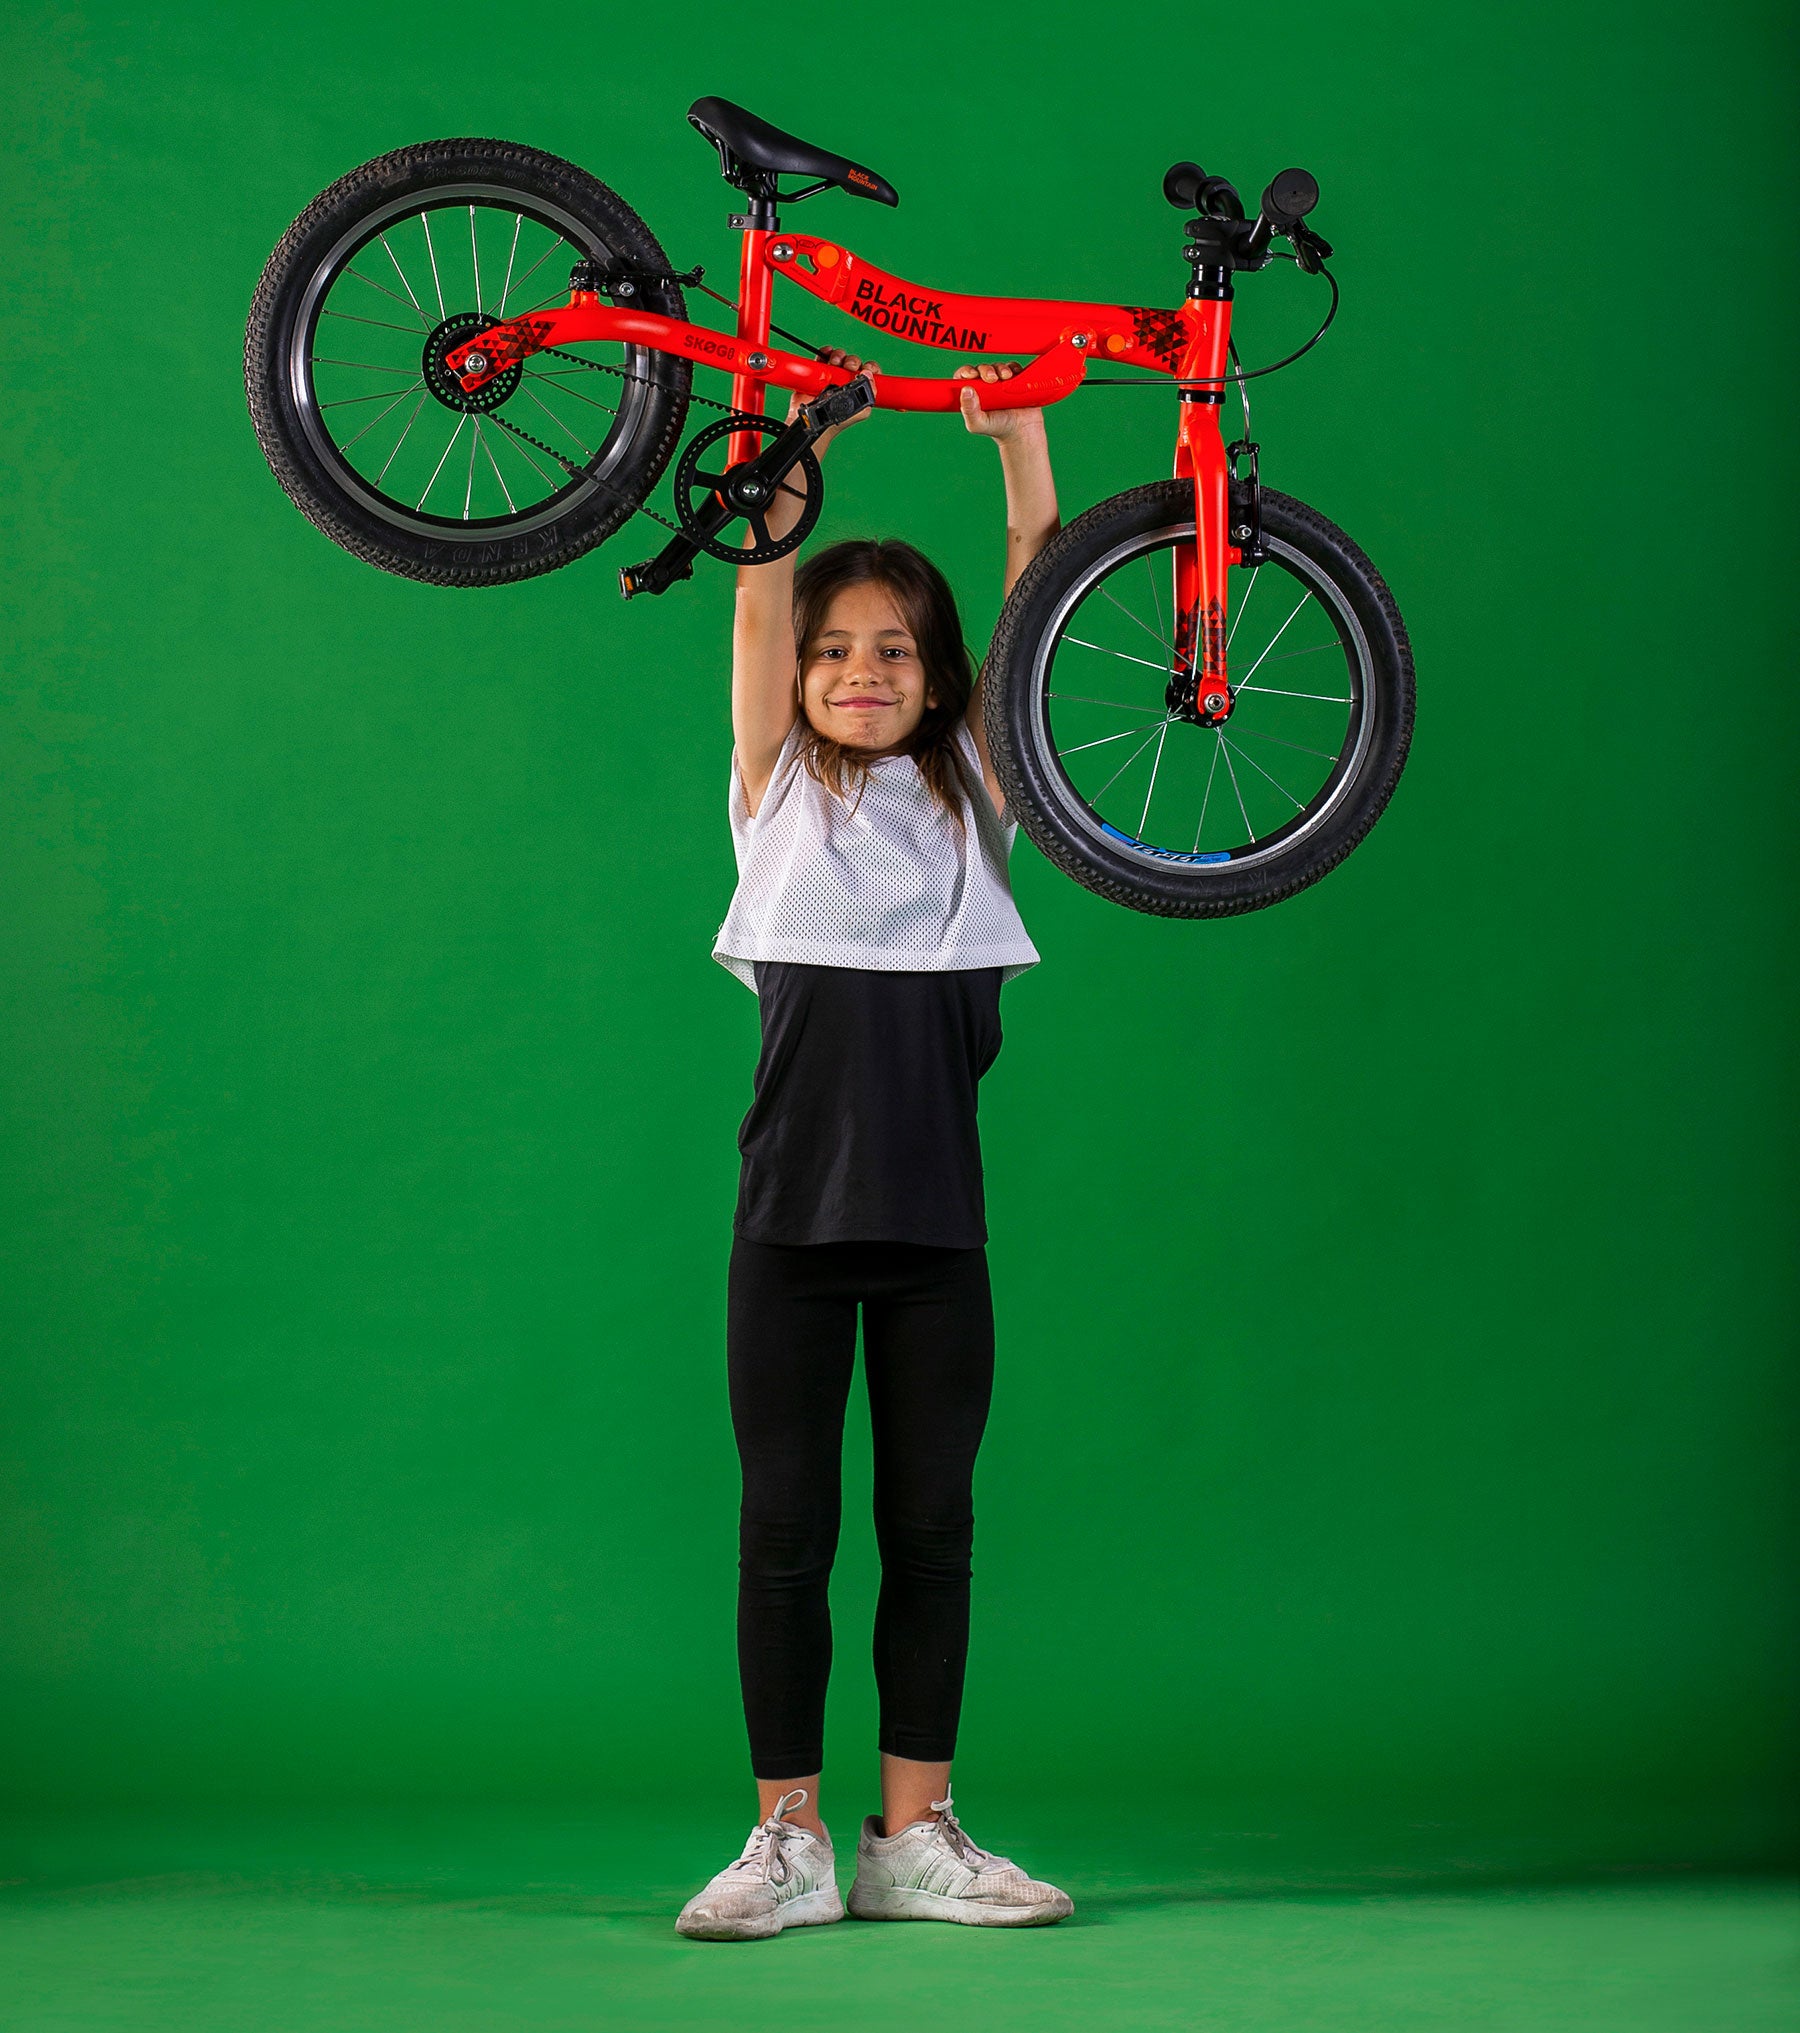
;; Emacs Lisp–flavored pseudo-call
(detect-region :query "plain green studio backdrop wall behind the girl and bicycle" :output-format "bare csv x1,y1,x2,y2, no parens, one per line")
0,0,1796,1862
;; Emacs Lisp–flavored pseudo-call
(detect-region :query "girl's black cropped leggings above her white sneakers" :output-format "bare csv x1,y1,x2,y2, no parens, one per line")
726,1236,995,1779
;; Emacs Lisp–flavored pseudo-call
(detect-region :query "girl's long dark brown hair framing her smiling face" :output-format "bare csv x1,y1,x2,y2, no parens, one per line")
793,537,974,819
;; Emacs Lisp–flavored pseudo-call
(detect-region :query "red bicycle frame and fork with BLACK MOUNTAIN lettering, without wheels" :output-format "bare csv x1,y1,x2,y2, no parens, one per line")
445,226,1239,691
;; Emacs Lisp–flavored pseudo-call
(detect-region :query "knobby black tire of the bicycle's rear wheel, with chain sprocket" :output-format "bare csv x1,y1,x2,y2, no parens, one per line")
244,140,692,586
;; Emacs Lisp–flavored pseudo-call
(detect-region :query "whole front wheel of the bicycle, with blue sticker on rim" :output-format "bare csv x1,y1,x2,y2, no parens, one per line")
982,480,1414,917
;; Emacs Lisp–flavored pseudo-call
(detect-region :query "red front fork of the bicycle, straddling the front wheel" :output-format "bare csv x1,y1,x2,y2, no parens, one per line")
1167,294,1241,728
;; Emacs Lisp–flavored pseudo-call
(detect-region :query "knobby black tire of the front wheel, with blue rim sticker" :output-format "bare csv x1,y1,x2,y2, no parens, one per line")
982,480,1414,917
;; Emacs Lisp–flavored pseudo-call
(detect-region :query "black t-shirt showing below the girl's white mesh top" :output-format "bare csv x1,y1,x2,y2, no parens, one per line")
734,960,1001,1248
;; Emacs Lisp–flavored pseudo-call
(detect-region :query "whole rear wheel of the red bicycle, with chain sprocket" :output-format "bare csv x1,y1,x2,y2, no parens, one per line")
244,140,689,586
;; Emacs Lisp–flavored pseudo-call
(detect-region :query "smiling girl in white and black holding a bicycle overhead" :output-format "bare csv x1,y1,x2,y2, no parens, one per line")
675,352,1072,1942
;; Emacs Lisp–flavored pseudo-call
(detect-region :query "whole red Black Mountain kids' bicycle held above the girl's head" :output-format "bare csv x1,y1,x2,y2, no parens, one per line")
244,100,1414,917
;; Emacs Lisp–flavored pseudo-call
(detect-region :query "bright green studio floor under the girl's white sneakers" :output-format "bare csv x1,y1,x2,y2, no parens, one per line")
0,1809,1800,2033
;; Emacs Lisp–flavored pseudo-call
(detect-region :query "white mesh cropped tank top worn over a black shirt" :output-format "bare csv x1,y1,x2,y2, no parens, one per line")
712,722,1037,992
